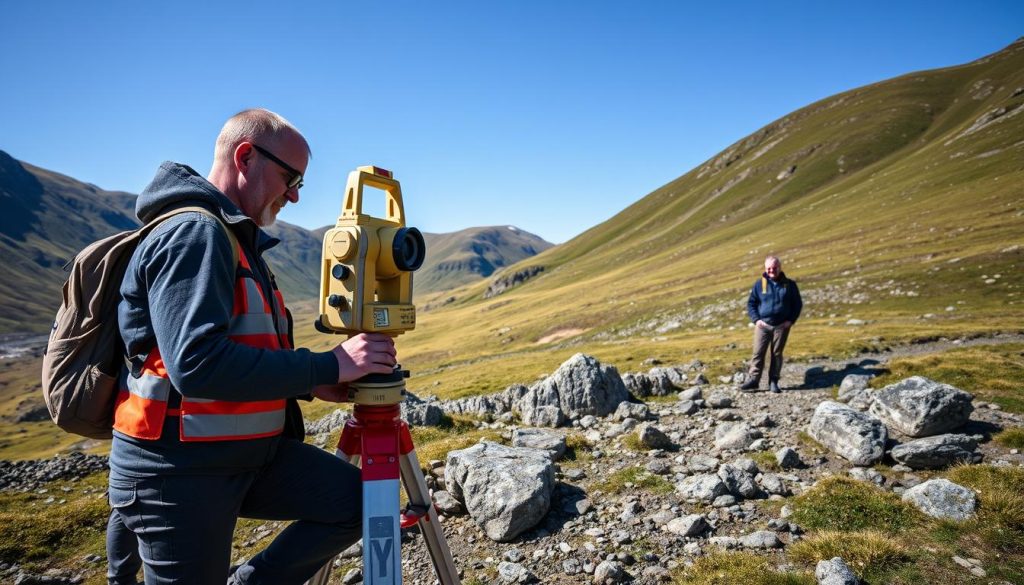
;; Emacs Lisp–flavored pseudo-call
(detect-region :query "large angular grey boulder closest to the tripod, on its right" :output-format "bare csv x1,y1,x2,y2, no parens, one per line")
444,442,555,542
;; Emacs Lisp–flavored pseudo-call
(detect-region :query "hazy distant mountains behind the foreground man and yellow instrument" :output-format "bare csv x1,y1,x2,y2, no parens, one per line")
0,151,551,333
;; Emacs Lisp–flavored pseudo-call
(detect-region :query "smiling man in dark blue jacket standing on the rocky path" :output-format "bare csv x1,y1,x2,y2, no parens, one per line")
739,256,804,392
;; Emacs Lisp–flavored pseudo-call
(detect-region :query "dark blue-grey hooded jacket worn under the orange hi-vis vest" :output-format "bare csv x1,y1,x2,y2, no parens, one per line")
111,162,338,476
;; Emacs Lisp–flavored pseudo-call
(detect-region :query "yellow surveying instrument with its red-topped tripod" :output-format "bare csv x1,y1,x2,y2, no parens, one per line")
306,166,460,585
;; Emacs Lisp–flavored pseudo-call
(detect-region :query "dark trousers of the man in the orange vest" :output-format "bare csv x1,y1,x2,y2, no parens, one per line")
110,440,362,585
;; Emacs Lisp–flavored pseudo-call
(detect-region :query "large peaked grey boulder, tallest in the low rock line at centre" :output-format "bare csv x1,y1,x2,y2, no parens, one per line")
516,353,629,426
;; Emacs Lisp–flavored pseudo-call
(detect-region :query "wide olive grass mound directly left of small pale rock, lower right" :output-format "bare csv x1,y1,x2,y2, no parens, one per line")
793,476,922,534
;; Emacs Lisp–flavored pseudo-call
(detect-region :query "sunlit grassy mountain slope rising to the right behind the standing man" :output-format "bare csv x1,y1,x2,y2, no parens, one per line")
352,40,1024,395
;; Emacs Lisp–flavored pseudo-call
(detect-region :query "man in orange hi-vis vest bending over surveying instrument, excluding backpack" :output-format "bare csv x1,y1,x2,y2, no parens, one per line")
110,110,395,585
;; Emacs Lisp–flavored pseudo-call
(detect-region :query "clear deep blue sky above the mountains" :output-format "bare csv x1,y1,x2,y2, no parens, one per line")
0,0,1024,243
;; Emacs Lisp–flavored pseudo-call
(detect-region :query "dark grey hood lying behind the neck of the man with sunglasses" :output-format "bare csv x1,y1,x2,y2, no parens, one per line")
135,161,278,249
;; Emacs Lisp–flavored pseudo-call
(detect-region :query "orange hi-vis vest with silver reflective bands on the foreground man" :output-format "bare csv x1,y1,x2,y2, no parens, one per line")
114,245,292,442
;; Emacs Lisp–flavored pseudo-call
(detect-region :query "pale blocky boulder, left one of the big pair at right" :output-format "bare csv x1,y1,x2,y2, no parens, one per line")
807,401,889,465
